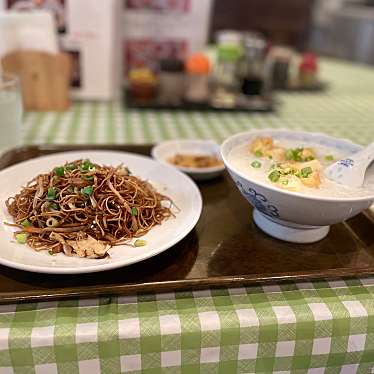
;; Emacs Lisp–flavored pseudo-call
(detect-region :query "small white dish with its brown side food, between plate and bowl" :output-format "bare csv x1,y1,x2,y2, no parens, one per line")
152,139,225,180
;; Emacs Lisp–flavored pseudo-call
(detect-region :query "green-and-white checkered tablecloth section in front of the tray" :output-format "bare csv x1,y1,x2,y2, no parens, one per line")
0,278,374,374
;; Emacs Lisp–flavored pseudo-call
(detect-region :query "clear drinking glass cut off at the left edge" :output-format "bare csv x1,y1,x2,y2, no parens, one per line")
0,72,22,152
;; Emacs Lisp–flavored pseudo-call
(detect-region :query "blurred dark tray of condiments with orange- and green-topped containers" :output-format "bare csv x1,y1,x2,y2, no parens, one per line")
126,31,274,111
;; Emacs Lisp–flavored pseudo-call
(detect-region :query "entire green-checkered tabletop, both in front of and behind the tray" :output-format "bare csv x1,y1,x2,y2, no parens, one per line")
0,59,374,374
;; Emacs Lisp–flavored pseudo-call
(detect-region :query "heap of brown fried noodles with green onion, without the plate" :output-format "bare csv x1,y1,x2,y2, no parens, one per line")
6,160,173,258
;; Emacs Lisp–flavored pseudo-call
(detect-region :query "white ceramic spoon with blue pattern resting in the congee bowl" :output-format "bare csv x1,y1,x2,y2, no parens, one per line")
325,142,374,187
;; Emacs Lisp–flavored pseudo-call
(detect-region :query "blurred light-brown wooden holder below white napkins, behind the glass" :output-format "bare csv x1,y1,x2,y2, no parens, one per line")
2,51,72,111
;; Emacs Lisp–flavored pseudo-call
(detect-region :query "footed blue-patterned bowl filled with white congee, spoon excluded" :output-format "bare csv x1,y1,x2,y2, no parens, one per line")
221,129,374,243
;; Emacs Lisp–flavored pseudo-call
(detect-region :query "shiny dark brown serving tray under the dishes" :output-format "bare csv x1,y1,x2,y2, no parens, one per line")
0,145,374,303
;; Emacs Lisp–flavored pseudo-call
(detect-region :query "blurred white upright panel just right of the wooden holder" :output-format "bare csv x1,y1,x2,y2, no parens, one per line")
65,0,121,100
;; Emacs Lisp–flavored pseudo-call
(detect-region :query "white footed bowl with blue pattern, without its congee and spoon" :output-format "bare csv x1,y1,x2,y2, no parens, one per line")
221,129,374,243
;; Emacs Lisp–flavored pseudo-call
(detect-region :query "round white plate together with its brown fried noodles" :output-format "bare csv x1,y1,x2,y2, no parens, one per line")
0,151,202,274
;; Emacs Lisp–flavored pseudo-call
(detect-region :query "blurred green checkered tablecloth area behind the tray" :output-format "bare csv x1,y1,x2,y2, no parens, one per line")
24,60,374,144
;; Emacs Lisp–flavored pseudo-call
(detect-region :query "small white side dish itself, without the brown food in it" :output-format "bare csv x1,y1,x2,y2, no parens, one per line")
151,139,225,181
